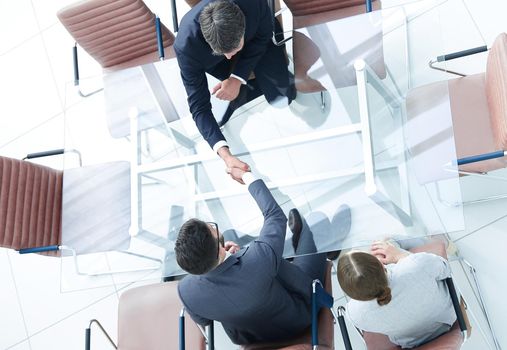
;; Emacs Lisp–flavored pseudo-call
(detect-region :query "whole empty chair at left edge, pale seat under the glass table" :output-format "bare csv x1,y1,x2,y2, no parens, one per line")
0,150,162,275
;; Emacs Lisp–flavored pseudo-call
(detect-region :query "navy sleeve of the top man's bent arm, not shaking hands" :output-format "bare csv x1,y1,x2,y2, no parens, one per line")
232,0,273,81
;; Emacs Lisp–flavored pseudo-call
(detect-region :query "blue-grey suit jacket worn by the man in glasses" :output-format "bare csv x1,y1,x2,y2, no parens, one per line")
178,180,312,344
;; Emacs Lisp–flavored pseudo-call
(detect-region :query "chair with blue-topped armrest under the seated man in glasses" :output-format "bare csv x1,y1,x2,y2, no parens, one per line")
241,262,335,350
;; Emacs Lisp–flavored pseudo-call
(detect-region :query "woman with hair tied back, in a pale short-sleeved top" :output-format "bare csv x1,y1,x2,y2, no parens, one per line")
338,242,456,348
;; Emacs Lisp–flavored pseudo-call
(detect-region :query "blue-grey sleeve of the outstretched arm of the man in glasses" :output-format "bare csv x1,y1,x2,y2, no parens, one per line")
248,180,287,274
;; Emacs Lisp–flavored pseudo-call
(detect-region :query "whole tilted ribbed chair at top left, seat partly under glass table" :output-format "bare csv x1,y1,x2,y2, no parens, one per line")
57,0,178,138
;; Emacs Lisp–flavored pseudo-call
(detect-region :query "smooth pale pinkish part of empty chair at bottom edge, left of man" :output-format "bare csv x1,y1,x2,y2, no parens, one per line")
118,282,205,350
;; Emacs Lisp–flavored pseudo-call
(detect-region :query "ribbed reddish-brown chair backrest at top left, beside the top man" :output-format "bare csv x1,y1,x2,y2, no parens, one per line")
57,0,174,71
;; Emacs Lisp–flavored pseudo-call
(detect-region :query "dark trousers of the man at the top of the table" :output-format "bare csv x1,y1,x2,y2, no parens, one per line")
207,21,295,112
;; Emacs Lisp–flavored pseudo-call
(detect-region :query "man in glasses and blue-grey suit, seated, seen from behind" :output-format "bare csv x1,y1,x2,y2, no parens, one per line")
175,169,350,344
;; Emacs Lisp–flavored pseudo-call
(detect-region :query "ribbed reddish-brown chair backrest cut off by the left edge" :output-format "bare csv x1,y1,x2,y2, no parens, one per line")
0,156,63,255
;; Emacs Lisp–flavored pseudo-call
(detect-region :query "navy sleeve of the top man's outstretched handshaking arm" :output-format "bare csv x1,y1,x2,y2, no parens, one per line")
175,45,225,148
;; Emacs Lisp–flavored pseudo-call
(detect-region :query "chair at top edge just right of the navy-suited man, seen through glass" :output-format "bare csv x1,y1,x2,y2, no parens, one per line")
285,0,386,109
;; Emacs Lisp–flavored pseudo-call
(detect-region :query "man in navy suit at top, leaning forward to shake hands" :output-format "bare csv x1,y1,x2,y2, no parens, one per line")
174,0,296,182
